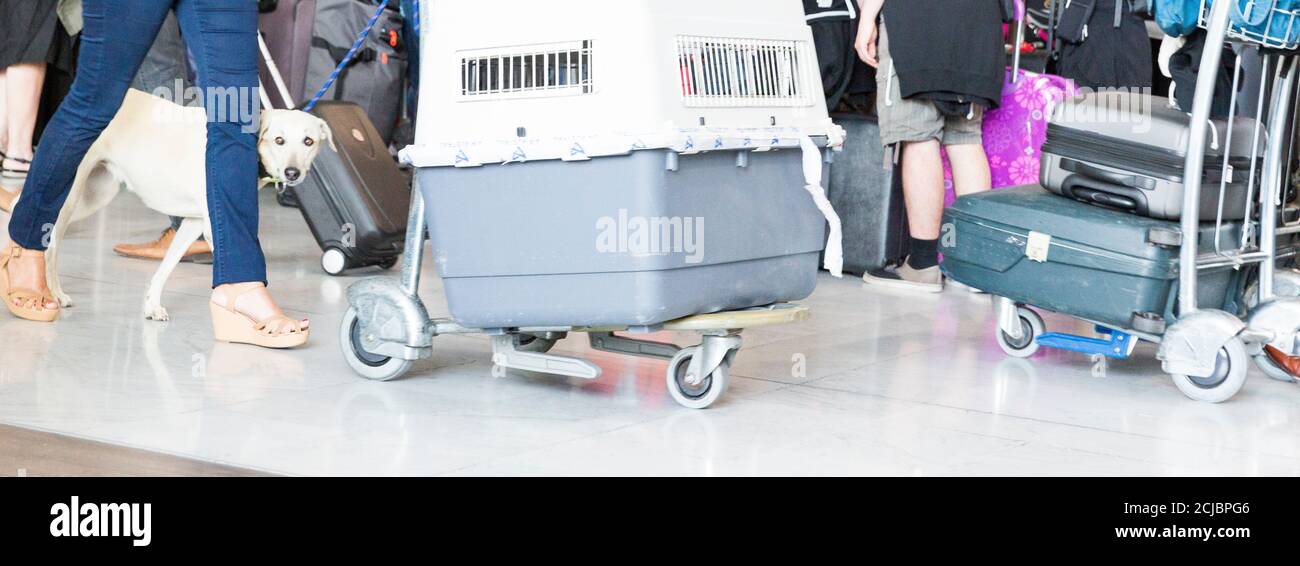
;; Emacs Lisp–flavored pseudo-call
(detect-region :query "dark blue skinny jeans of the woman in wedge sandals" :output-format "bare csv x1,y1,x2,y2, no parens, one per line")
9,0,267,286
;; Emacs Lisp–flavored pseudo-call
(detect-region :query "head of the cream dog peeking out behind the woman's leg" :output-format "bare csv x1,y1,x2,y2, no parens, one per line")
257,111,337,186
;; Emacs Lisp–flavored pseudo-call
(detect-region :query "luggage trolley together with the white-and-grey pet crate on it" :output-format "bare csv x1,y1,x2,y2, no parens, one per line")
339,0,842,409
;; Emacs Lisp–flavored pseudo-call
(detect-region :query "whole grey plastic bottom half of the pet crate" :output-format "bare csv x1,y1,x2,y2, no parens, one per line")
416,150,826,328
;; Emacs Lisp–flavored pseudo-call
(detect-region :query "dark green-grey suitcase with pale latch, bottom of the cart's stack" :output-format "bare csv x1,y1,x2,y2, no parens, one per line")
940,185,1245,333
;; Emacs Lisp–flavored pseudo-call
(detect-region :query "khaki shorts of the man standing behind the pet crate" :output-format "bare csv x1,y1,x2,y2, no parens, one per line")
876,22,984,147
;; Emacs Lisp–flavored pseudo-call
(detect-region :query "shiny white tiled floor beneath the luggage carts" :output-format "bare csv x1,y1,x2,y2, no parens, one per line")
0,178,1300,475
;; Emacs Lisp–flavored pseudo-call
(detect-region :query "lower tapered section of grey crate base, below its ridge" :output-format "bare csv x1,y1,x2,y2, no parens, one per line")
443,252,818,328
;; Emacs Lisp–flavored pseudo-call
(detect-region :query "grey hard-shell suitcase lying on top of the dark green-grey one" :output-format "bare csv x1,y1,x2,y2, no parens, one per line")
1041,91,1264,220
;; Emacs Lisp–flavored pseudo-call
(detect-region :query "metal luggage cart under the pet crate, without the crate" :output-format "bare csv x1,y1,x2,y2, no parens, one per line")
339,190,809,409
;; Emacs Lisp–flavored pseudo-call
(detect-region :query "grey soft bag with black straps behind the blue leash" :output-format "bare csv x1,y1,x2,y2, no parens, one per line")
303,0,407,143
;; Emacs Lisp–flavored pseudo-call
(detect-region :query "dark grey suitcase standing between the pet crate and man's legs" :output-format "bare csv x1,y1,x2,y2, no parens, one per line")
827,115,907,275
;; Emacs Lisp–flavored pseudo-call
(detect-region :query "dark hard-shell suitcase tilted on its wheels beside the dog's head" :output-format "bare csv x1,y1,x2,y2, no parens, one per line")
291,101,411,275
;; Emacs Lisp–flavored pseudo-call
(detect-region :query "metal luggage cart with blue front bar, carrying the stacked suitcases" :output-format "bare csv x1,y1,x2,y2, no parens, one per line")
977,1,1300,402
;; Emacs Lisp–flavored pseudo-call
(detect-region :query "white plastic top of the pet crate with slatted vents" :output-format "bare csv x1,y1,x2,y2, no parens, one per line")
403,0,842,167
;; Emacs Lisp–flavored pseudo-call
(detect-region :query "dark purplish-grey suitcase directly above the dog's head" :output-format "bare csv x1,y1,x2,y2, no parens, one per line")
259,0,320,108
